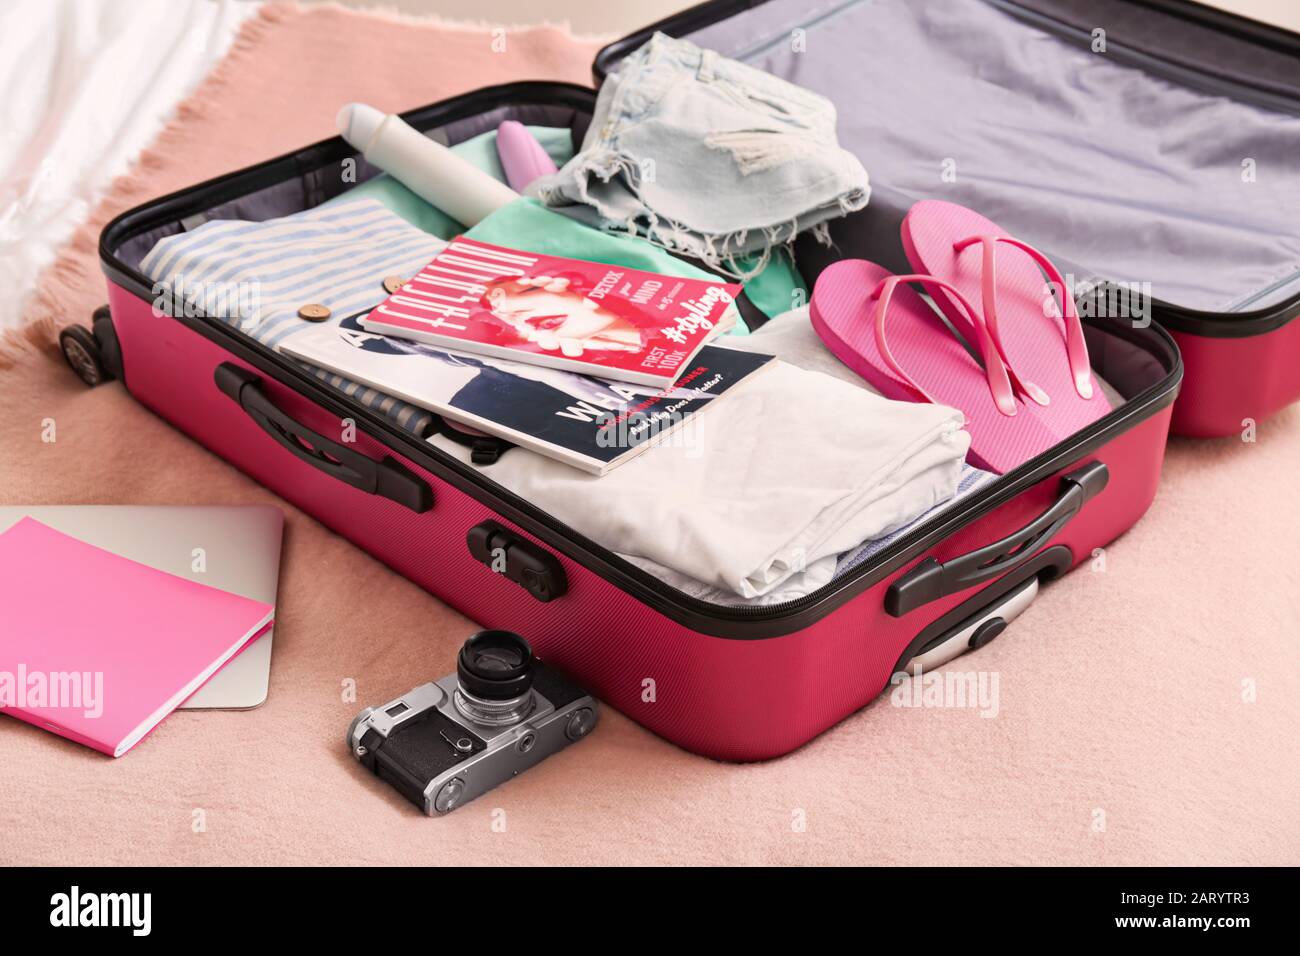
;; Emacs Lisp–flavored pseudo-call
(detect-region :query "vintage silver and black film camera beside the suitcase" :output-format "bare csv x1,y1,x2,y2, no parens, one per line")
347,631,597,817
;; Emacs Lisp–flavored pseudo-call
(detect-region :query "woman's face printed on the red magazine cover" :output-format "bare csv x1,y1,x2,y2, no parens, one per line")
488,276,637,349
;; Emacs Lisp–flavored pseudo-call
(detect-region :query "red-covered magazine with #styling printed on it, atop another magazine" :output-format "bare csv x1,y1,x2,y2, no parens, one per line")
361,238,741,388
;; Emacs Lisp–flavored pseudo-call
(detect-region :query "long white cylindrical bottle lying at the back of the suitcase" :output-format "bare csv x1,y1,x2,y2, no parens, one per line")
337,103,519,226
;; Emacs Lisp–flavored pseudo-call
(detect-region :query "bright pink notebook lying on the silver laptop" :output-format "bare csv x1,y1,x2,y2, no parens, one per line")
0,518,274,757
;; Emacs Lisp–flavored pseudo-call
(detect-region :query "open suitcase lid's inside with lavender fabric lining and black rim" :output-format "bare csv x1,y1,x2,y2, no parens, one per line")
593,0,1300,338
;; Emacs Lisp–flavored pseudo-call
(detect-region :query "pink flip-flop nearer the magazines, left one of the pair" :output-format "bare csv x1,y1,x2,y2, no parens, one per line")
810,259,1057,475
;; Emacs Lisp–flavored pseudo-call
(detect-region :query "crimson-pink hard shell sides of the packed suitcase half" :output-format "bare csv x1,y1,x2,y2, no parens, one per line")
109,280,1171,761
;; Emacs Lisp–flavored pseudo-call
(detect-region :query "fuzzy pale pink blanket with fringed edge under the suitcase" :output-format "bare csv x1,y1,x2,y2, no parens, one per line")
0,7,1300,865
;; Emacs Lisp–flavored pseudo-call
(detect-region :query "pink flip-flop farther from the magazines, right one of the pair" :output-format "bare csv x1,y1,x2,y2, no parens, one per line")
902,199,1110,438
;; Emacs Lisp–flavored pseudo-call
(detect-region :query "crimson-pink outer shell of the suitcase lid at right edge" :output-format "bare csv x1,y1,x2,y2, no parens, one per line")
1169,317,1300,438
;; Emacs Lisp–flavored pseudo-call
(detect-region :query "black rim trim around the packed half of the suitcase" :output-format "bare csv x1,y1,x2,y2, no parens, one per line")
99,82,1183,640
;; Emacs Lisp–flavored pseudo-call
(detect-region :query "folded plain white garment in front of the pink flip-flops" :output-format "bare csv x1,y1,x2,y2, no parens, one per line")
430,347,970,598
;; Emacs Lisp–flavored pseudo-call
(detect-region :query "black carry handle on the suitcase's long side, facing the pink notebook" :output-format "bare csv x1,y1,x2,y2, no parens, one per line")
212,362,433,514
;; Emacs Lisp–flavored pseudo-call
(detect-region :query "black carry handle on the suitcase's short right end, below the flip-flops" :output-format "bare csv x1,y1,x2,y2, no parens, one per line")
885,462,1110,618
